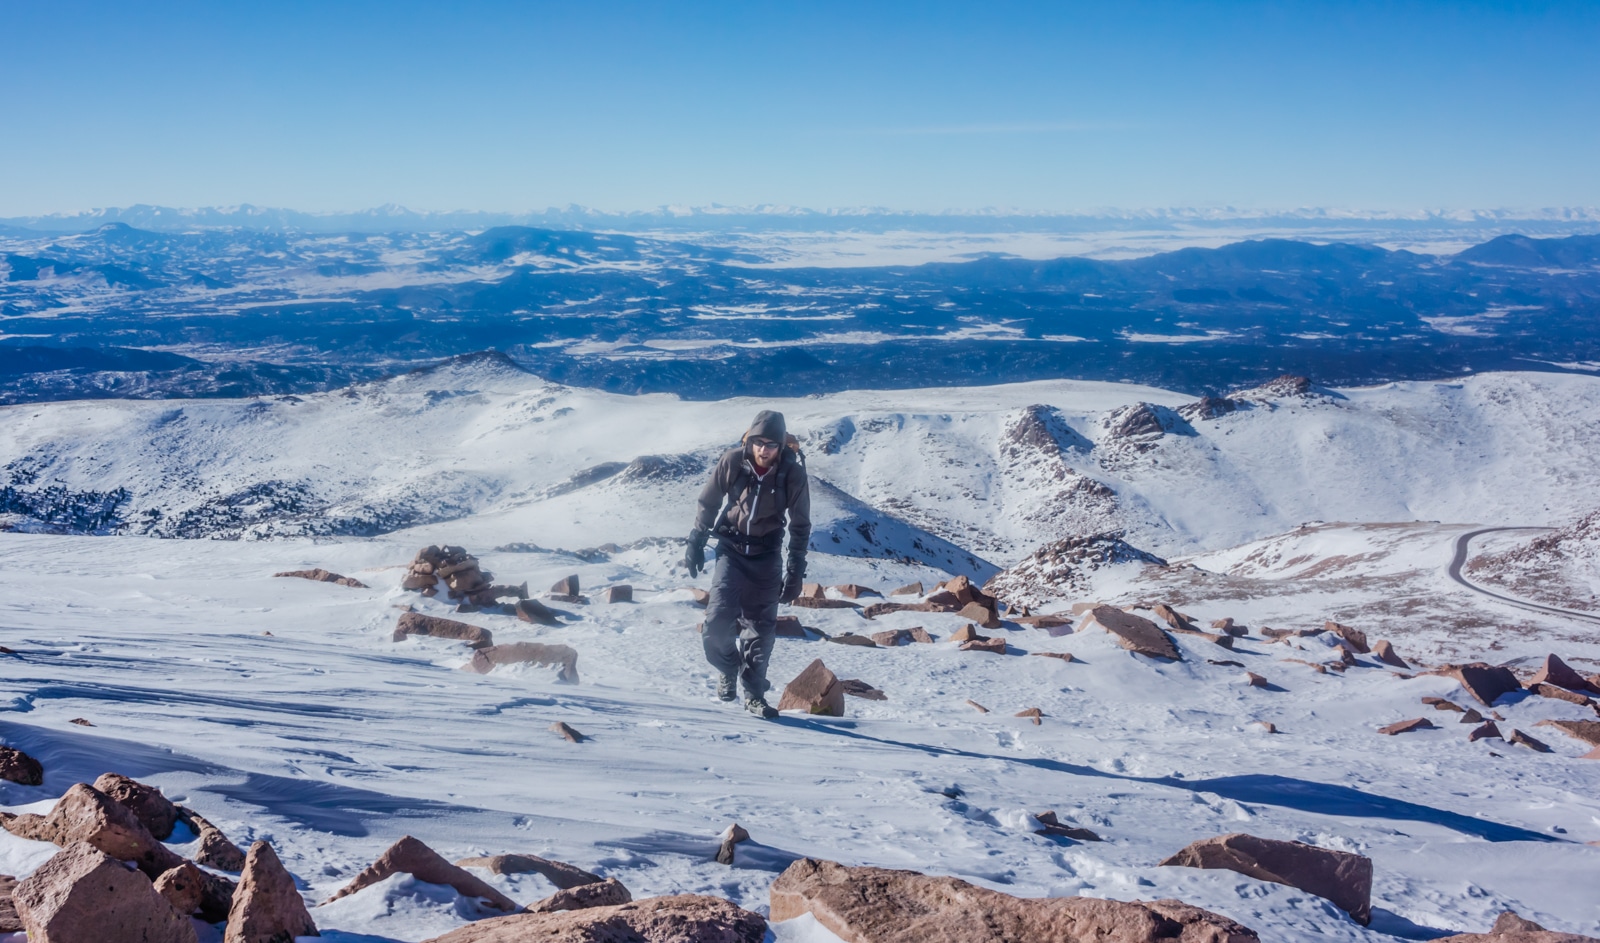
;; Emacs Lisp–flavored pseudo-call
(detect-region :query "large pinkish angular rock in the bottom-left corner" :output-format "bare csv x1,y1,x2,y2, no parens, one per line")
11,842,197,943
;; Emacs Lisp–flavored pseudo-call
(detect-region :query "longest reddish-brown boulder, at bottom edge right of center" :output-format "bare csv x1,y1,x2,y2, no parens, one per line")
770,858,1258,943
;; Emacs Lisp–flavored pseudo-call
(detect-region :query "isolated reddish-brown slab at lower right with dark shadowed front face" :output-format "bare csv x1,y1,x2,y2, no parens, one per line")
1162,833,1373,927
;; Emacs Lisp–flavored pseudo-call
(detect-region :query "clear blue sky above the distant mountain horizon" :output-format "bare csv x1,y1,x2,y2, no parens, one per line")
0,0,1600,216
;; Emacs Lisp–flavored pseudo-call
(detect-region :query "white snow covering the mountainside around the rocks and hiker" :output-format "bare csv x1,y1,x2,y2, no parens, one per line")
0,365,1600,943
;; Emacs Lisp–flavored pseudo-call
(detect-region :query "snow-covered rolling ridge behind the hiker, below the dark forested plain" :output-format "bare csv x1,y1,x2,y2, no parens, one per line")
0,355,1600,566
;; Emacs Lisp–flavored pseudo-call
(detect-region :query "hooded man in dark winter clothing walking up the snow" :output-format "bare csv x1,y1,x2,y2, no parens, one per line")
683,410,811,717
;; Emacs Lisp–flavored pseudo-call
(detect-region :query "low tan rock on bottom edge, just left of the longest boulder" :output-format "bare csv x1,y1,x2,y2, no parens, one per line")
427,893,766,943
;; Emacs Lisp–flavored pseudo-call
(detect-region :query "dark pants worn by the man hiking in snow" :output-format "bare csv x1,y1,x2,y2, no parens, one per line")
702,546,784,696
